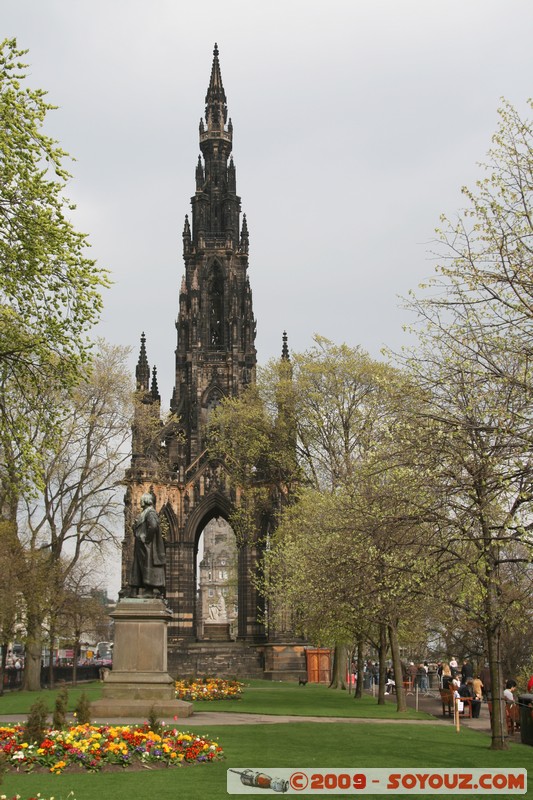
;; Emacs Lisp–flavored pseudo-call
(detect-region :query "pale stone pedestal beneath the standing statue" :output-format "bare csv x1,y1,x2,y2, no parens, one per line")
91,597,192,720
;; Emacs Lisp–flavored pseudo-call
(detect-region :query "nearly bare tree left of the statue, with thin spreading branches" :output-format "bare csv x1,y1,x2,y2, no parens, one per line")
19,342,133,688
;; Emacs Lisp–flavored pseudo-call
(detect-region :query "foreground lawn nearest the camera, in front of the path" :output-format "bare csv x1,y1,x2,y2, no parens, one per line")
1,721,533,800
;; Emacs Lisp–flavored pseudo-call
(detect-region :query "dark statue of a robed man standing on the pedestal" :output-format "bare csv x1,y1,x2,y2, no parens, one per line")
130,494,166,597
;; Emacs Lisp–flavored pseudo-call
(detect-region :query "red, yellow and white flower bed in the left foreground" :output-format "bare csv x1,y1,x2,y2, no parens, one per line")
0,725,223,774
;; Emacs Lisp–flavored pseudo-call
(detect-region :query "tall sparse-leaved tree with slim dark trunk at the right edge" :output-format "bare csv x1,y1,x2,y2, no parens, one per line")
408,102,533,749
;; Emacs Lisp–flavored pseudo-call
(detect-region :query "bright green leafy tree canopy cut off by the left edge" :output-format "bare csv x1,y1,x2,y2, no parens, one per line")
0,39,109,506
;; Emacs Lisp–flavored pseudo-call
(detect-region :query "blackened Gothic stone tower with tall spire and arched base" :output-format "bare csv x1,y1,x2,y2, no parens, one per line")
123,40,278,675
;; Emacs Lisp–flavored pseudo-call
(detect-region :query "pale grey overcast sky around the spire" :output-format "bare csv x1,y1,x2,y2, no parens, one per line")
5,0,533,592
